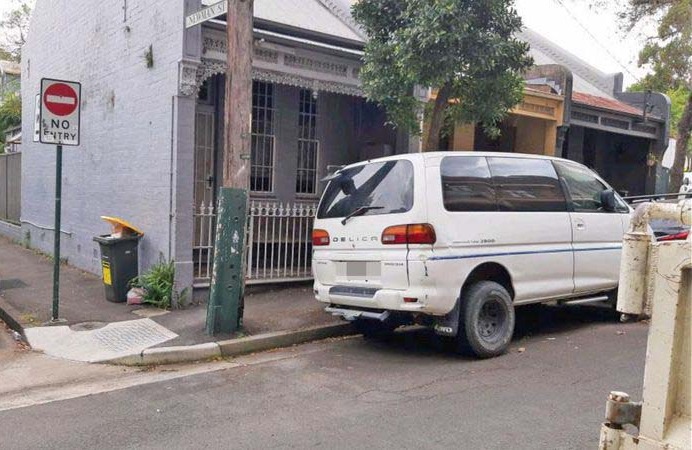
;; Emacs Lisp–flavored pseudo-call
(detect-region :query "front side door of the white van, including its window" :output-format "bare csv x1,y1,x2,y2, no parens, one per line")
555,161,629,293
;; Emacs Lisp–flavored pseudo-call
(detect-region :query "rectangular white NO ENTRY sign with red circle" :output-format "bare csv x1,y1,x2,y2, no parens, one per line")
39,78,82,145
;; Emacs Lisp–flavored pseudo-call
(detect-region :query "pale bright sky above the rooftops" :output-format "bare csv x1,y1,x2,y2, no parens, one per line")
0,0,651,86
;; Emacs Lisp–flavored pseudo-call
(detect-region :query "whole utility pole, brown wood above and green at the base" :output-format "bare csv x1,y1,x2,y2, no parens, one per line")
206,0,254,335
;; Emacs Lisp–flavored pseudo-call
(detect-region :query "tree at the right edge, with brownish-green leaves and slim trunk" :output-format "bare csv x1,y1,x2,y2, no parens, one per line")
620,0,692,192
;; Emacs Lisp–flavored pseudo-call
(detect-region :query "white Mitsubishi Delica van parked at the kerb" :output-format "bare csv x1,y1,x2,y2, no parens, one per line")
312,152,631,357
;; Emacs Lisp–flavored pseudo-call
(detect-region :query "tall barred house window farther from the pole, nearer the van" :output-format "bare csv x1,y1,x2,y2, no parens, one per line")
296,89,320,194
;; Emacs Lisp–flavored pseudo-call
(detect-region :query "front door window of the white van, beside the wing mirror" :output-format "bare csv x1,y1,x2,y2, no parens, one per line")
555,161,621,212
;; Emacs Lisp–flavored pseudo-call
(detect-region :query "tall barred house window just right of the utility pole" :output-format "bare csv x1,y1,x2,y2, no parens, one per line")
250,81,275,192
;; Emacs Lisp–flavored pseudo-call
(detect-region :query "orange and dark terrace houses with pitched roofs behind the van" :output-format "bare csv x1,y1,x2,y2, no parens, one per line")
449,29,670,195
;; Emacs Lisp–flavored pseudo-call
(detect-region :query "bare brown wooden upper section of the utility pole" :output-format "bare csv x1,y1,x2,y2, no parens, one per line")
222,0,254,189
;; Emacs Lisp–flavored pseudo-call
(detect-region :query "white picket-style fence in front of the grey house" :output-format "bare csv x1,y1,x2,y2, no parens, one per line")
193,200,317,287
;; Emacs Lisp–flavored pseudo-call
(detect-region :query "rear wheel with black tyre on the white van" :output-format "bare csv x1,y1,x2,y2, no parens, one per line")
456,281,515,358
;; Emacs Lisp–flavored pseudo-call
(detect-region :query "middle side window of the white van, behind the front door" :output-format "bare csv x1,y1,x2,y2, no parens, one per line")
488,157,567,212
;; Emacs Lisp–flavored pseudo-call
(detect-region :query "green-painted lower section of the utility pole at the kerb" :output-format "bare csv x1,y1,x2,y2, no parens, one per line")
206,187,247,336
